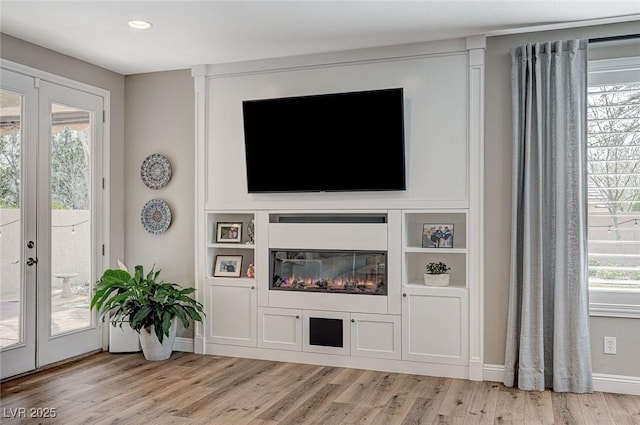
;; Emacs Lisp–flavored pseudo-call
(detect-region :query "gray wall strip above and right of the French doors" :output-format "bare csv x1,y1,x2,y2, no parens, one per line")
0,33,125,272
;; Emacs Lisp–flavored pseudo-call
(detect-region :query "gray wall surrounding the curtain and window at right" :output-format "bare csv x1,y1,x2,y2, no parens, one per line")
484,22,640,376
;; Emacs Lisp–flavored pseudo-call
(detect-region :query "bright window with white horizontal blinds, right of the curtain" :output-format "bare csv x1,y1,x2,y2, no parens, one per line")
587,57,640,313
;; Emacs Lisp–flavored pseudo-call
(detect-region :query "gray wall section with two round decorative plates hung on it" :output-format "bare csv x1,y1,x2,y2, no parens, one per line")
124,70,195,336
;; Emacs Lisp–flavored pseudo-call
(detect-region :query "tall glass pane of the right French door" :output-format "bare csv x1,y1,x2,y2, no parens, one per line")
50,103,92,335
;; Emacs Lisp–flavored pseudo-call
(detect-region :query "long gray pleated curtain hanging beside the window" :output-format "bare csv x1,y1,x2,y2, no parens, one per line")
504,40,593,393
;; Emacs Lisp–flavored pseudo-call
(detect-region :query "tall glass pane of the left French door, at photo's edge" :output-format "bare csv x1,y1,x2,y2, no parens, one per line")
0,91,24,349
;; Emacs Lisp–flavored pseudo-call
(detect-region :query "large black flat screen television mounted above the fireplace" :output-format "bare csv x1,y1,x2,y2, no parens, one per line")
242,88,406,193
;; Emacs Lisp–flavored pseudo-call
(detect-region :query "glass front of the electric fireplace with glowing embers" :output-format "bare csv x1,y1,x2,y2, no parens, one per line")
270,250,387,295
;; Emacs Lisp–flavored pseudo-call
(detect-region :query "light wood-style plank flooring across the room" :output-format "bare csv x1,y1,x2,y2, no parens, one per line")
0,352,640,425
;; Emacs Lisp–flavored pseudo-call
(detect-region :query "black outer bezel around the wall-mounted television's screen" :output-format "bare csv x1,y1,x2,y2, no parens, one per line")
242,87,407,194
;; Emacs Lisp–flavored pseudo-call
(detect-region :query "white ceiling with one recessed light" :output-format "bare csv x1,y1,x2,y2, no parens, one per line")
0,0,640,75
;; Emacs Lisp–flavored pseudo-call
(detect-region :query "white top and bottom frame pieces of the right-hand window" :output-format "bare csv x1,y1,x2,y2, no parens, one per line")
588,56,640,319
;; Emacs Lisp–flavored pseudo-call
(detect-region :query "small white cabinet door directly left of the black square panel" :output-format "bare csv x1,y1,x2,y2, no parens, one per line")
258,307,302,351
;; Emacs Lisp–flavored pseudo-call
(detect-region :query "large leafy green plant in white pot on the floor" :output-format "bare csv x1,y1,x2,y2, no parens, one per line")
91,264,204,360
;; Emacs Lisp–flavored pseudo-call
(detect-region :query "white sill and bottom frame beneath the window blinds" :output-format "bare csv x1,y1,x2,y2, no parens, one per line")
589,288,640,319
